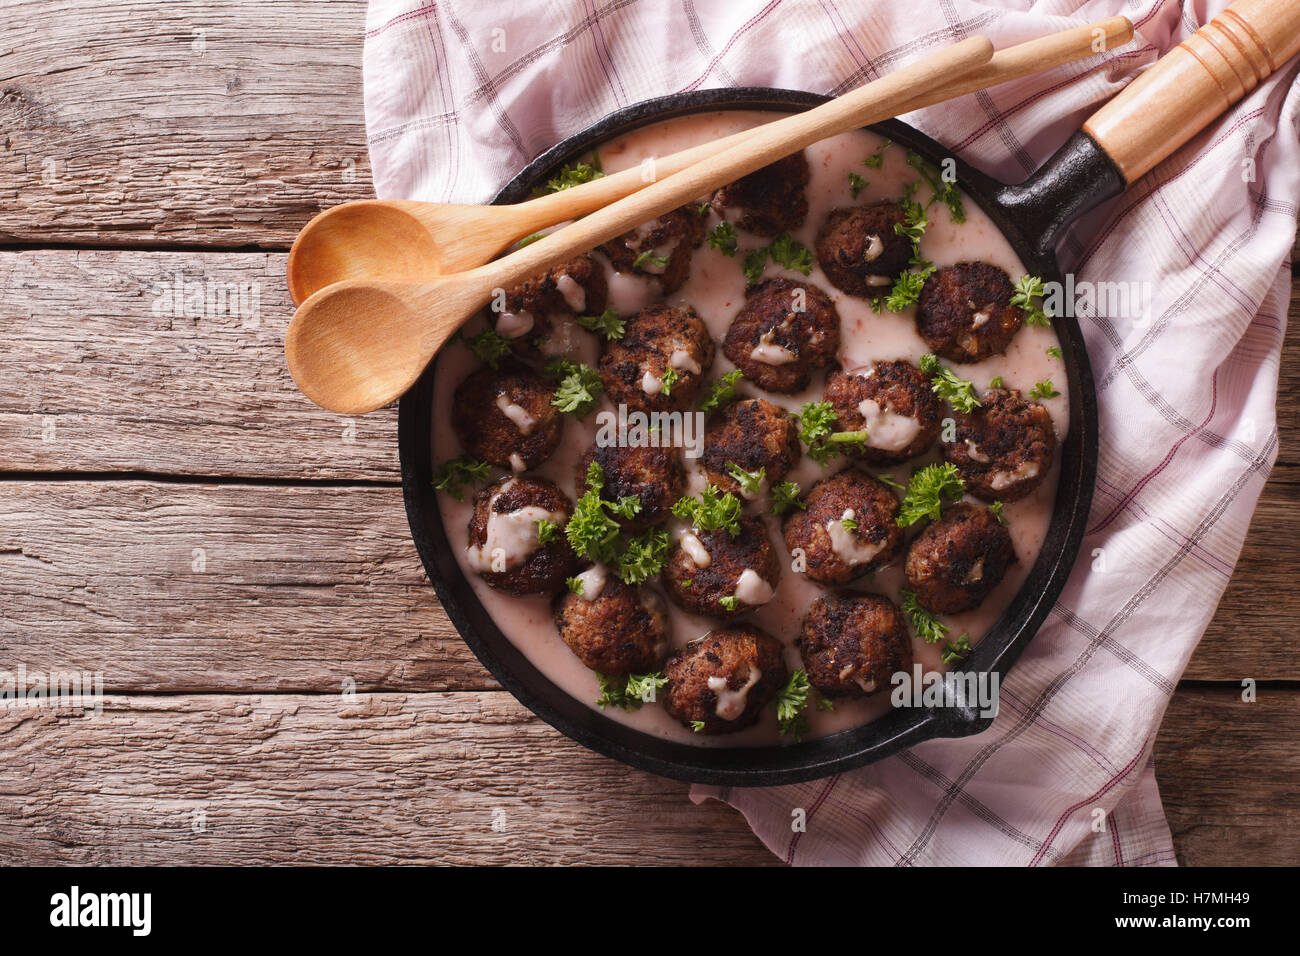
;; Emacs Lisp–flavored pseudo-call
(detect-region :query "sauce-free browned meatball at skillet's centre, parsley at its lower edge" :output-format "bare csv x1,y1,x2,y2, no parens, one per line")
702,398,802,497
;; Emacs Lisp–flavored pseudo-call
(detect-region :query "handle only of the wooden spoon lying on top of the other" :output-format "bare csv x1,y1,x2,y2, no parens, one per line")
462,36,993,293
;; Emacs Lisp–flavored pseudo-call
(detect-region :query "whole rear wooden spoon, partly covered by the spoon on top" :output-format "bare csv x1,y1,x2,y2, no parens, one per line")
289,17,1132,304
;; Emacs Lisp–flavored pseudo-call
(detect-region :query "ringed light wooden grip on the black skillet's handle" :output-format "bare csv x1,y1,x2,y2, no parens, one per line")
1083,0,1300,183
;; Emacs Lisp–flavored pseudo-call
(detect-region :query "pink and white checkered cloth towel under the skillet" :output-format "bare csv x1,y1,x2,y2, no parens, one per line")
365,0,1300,866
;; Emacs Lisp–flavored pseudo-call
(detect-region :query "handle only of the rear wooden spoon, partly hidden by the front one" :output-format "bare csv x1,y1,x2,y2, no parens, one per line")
511,17,1134,241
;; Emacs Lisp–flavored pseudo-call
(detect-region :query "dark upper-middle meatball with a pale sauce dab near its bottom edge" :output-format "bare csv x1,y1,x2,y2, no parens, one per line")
723,278,840,394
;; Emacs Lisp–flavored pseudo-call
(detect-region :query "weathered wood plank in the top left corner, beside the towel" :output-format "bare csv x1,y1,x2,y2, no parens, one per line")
0,0,373,248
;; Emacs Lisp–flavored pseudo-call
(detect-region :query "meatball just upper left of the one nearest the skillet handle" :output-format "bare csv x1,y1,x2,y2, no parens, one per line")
815,202,913,299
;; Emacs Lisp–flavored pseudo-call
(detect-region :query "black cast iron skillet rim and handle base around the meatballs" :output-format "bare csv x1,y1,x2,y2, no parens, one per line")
399,88,1123,787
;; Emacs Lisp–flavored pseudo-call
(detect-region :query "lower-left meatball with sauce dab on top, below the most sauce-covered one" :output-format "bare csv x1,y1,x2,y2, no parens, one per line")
555,567,668,678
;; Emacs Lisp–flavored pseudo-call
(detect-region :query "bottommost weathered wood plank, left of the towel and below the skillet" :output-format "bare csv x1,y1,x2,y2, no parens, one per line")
0,692,777,865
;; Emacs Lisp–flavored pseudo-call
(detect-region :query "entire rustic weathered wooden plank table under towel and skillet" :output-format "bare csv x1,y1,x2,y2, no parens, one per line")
0,0,1300,864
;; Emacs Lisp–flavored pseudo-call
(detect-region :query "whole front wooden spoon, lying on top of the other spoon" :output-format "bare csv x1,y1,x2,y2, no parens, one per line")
285,36,993,415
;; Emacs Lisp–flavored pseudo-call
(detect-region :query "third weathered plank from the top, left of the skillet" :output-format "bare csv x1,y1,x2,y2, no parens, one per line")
0,481,497,693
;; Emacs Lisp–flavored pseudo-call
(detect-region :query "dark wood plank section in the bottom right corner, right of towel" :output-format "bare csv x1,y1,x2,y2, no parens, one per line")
1156,687,1300,866
